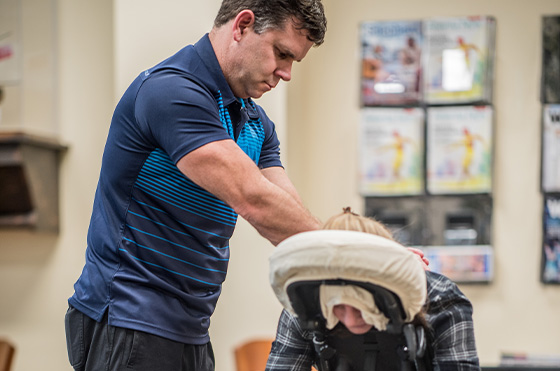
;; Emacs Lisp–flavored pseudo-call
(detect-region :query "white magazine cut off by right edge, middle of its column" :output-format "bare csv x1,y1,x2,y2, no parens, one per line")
542,104,560,192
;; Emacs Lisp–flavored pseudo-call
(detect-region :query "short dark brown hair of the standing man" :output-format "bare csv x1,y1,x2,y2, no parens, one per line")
214,0,327,46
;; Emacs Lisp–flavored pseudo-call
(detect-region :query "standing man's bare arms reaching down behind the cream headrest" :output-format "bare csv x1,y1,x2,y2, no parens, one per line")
177,140,320,245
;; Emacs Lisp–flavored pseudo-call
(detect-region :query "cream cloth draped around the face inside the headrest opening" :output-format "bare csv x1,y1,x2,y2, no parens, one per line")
319,285,389,331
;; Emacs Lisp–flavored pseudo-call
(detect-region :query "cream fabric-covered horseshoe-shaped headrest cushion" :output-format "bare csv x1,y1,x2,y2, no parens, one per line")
269,230,427,321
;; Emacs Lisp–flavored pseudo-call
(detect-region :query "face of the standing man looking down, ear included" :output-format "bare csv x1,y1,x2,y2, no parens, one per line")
226,21,313,98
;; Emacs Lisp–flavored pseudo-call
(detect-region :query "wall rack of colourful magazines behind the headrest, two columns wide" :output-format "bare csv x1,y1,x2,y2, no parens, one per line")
359,15,494,283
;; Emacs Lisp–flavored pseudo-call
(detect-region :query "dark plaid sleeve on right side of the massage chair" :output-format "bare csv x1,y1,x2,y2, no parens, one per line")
427,272,480,371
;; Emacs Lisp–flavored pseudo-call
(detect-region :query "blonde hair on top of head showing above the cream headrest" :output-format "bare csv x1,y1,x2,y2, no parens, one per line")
322,207,395,241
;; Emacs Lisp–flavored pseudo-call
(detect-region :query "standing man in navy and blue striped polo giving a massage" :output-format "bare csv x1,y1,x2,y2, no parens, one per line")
66,0,326,371
